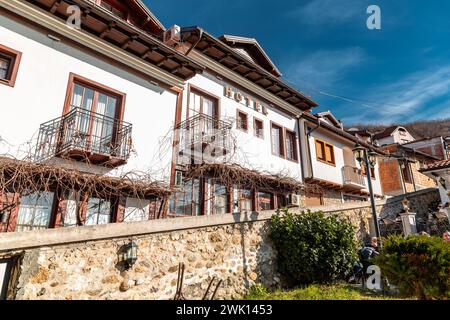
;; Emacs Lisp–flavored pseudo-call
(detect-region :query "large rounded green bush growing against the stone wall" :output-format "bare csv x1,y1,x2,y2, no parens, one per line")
270,210,357,285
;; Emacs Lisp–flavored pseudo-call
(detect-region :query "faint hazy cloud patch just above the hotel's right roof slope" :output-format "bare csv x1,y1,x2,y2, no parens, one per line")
286,47,366,90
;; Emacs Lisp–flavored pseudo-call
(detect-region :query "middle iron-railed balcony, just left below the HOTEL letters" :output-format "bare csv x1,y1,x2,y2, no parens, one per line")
176,114,234,165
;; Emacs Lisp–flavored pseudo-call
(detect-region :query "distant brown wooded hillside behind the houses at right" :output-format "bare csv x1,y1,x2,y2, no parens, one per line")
349,118,450,139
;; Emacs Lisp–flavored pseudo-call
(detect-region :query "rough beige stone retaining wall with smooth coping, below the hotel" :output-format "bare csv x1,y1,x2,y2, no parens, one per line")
0,190,439,299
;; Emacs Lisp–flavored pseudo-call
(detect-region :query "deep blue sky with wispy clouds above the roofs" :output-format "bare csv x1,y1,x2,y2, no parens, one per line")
145,0,450,125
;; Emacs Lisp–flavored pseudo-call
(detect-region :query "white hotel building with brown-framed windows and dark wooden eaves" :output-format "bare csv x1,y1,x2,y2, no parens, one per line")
0,0,381,231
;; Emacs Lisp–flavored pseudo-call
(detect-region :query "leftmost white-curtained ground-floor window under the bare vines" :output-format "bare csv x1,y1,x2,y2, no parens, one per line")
16,192,54,231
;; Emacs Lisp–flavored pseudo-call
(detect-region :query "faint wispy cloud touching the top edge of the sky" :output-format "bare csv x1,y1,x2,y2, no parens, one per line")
288,0,367,25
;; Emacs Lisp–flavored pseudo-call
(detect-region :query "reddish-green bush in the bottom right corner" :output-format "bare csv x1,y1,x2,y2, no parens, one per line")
374,235,450,299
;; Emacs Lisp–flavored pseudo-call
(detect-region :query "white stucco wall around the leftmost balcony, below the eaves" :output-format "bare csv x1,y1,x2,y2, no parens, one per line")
0,14,176,181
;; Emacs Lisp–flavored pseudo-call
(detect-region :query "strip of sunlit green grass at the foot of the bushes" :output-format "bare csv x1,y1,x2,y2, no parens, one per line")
244,284,410,300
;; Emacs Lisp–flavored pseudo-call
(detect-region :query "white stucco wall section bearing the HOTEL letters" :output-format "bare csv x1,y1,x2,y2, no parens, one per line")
183,72,302,181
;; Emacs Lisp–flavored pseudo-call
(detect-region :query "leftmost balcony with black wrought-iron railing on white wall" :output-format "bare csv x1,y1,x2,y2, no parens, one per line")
35,108,132,168
